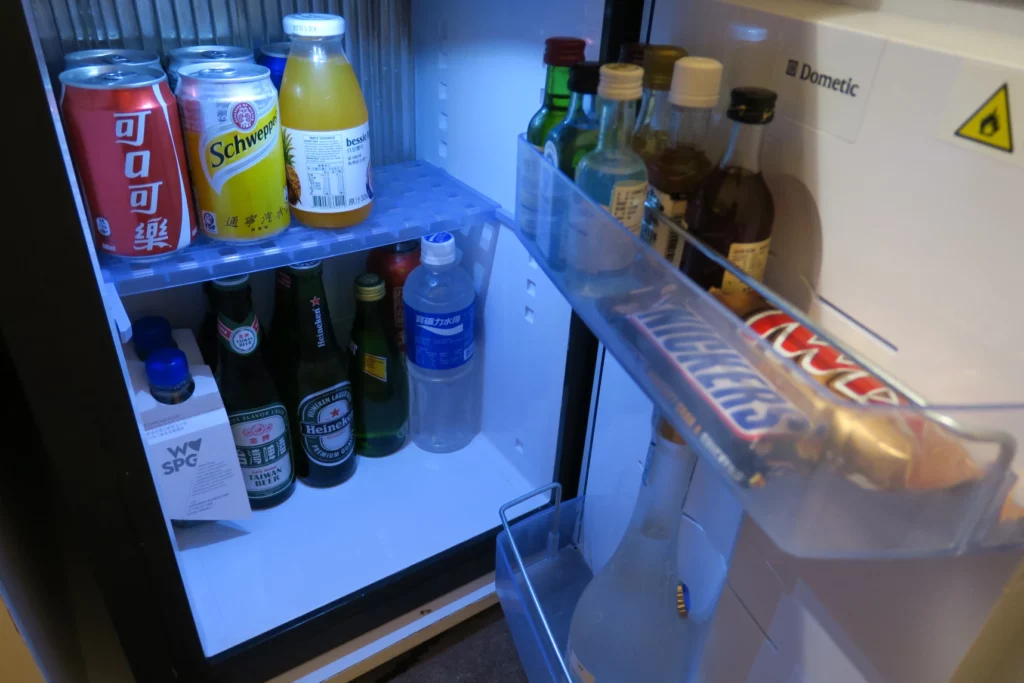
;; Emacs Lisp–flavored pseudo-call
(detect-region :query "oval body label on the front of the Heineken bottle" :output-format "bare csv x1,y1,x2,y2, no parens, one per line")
299,381,355,466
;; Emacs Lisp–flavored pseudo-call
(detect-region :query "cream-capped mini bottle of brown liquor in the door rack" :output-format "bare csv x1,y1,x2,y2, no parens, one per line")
634,57,722,267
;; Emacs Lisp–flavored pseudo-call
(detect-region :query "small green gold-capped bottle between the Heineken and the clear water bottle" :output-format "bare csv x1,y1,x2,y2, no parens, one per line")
350,272,409,457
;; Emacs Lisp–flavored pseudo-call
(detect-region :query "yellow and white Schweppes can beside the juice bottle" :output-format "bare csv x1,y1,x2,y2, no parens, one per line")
177,61,290,242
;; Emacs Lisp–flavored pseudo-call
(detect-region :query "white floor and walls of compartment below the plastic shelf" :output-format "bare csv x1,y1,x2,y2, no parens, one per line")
126,223,570,655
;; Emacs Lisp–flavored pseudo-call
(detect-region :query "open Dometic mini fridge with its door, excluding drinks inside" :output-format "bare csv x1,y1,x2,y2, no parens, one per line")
0,0,1024,683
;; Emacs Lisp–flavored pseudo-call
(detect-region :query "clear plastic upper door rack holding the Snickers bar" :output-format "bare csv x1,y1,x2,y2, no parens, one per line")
515,138,1024,558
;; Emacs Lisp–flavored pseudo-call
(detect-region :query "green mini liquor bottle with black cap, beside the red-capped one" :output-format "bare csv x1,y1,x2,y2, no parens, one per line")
544,61,601,178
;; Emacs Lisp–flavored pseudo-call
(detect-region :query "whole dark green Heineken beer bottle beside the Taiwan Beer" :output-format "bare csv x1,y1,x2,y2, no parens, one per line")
286,261,355,486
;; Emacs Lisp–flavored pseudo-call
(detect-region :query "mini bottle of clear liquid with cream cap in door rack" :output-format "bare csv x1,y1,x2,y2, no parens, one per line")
568,63,647,280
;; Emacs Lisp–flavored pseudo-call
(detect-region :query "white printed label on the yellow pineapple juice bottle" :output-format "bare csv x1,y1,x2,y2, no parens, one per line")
284,124,374,213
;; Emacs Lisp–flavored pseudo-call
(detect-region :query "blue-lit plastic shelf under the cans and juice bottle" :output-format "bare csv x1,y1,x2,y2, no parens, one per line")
99,161,498,296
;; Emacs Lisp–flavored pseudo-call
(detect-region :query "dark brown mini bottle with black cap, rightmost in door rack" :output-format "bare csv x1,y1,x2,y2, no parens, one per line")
682,87,776,294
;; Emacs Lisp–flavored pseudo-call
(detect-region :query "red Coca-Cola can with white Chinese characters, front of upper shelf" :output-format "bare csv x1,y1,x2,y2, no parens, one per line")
60,66,196,258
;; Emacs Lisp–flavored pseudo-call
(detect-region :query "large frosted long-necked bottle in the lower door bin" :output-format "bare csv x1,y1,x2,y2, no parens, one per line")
566,419,703,683
